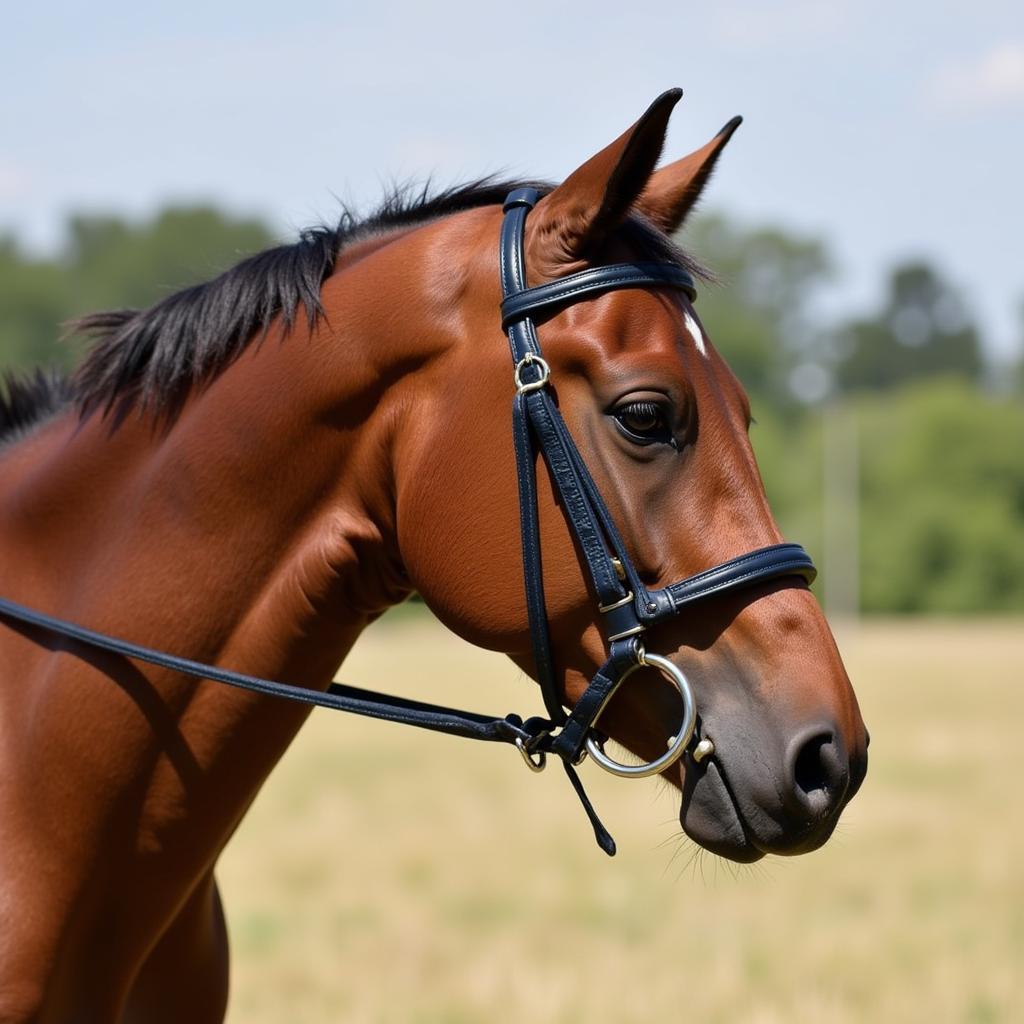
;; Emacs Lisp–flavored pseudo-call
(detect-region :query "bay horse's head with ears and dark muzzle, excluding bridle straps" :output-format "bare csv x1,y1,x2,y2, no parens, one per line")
394,91,867,861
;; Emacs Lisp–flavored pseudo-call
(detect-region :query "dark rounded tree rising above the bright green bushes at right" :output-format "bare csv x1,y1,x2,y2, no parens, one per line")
836,261,982,391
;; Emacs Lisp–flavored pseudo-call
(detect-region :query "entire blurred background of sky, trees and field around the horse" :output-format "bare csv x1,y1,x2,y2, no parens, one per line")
8,0,1024,1022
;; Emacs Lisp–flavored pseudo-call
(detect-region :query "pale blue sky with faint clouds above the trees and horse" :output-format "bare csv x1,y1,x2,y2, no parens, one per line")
0,0,1024,355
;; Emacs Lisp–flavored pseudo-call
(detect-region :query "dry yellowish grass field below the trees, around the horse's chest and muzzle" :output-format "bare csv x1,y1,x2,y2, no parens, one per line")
220,612,1024,1024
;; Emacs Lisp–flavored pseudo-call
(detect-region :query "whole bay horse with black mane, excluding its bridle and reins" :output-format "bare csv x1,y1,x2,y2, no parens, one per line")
0,90,867,1024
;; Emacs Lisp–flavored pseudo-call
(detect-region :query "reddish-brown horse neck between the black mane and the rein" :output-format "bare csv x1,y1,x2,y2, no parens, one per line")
0,224,448,687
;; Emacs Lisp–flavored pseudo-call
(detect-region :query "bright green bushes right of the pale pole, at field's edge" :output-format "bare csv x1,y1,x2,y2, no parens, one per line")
860,378,1024,613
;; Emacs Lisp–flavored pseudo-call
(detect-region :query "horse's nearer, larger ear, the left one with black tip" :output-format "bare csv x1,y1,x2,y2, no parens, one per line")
527,89,683,272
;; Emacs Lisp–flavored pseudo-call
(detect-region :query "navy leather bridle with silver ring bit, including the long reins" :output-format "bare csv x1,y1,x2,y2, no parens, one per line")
0,188,816,855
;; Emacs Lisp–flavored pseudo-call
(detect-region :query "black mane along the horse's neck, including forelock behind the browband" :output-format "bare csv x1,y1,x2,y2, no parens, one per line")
0,178,700,437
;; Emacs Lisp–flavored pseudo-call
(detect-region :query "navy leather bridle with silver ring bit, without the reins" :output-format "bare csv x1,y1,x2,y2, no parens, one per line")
501,188,817,853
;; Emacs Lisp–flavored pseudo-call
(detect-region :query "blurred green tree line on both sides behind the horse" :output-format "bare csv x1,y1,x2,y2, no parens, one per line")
0,207,1024,613
